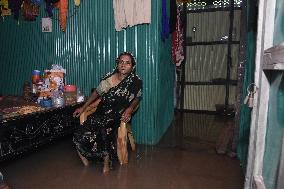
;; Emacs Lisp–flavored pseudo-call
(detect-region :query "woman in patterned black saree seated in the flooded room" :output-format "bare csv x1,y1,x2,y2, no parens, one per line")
73,52,142,174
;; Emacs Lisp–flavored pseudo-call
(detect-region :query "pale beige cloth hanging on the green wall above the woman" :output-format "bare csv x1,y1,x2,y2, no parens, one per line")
113,0,151,31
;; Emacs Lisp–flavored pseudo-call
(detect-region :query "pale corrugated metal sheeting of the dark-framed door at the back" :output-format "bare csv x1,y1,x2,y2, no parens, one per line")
184,11,240,111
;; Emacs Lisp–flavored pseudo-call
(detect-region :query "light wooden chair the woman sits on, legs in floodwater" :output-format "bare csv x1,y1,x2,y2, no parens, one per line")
80,98,139,164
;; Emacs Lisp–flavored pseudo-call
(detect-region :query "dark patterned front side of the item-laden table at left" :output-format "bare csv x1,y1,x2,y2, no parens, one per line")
0,104,81,162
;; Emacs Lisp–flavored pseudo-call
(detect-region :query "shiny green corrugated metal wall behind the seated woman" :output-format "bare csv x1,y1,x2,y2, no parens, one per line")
0,0,174,144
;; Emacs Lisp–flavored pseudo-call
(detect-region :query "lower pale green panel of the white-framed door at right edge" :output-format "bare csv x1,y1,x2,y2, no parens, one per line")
262,71,284,189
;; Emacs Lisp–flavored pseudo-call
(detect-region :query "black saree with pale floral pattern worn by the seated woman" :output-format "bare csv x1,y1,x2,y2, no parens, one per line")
73,72,142,164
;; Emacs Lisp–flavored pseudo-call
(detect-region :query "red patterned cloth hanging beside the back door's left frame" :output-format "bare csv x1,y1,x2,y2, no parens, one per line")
172,8,184,66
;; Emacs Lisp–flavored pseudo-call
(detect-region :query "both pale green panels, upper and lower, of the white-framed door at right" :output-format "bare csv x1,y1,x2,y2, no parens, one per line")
262,0,284,189
